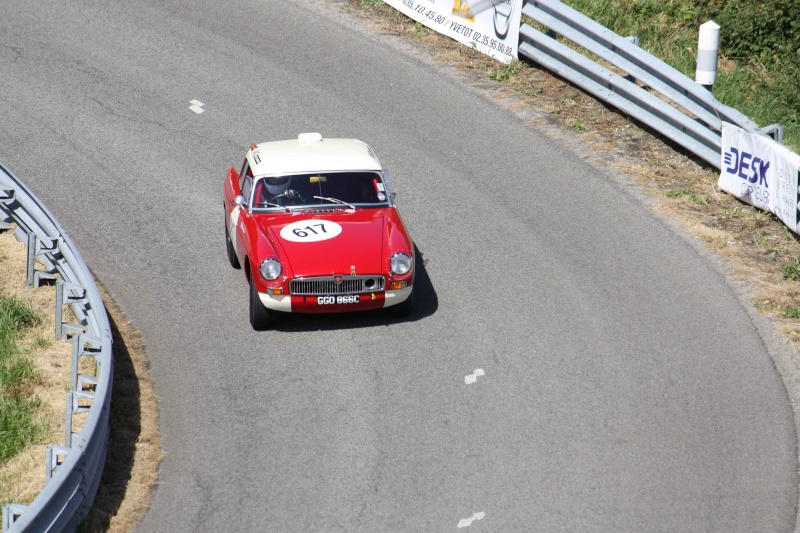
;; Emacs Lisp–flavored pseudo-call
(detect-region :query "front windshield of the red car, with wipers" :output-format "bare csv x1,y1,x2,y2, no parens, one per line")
252,171,388,209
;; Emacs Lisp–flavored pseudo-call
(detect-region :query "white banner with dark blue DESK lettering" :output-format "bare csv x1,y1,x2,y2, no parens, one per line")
718,122,800,233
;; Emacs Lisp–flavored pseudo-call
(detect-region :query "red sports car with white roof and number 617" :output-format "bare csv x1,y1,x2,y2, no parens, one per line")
225,133,415,330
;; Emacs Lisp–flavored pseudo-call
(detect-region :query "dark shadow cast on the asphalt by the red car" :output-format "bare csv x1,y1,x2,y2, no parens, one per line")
270,244,439,332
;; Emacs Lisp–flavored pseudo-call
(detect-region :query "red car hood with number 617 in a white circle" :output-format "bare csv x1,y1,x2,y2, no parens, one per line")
260,210,386,277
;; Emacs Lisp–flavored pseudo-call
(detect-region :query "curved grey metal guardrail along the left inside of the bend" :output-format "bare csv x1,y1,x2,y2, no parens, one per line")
0,164,114,533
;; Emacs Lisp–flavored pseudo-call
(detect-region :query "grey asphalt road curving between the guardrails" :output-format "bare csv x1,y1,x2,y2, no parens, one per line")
0,0,798,532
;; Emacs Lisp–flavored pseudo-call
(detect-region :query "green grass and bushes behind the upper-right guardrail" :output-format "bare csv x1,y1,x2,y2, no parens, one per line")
565,0,800,151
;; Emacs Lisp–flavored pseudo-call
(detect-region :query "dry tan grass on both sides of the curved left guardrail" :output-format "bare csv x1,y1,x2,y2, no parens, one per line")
0,227,162,531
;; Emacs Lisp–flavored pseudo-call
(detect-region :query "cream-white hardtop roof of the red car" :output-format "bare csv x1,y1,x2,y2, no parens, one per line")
247,133,383,176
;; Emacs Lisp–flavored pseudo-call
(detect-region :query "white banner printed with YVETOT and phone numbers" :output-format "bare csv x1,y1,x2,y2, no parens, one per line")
384,0,522,63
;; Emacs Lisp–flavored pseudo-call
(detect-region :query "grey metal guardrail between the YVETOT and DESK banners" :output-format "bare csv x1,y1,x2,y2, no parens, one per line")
519,0,783,169
